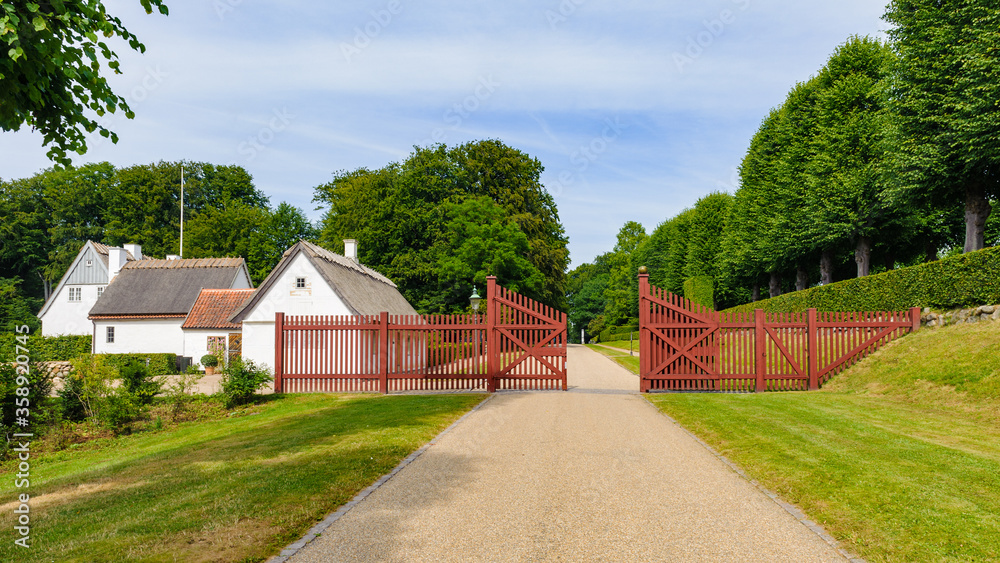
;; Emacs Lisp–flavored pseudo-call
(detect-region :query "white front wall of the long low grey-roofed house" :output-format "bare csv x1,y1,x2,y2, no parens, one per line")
94,318,186,354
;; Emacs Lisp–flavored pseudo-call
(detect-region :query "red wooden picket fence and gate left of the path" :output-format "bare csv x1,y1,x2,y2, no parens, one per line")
274,277,566,393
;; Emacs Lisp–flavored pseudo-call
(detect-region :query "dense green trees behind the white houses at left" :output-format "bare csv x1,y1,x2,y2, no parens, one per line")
0,162,316,330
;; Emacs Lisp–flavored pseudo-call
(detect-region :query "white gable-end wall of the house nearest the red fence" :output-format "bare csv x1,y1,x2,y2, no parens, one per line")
243,253,351,369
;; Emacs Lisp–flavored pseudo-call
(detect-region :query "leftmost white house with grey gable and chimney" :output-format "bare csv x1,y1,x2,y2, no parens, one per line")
38,240,142,336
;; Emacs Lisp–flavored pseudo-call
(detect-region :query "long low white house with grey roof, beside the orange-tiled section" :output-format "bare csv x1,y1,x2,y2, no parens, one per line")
89,258,253,361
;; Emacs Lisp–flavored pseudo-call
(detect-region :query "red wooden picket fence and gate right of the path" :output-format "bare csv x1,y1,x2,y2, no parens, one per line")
639,274,920,392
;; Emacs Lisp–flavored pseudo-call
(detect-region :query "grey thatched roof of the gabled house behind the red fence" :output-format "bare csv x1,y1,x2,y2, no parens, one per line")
232,240,417,322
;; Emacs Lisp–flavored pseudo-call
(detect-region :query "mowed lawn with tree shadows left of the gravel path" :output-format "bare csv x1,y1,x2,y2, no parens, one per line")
0,395,484,562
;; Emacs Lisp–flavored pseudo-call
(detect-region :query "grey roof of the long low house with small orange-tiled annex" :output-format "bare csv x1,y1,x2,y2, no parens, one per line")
90,258,246,317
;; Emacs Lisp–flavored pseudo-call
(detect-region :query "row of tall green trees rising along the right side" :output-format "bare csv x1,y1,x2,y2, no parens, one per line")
569,0,1000,340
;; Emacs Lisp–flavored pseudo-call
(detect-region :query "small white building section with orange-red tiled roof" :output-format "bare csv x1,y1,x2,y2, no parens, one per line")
181,289,254,363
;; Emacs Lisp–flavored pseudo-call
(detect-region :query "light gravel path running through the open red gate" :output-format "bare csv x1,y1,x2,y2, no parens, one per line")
289,346,845,563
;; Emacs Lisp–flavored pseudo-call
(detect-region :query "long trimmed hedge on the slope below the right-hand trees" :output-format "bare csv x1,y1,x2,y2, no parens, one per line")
726,246,1000,313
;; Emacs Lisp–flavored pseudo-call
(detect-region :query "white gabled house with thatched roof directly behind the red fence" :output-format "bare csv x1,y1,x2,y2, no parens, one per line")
230,240,417,367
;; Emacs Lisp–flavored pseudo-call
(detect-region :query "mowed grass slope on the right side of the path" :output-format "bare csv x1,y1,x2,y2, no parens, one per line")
650,323,1000,561
